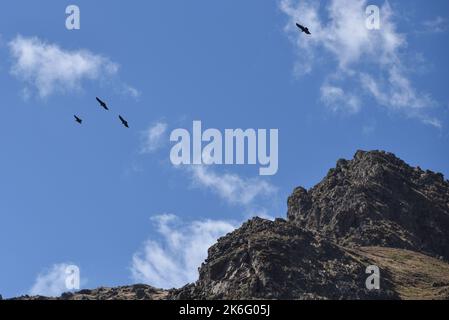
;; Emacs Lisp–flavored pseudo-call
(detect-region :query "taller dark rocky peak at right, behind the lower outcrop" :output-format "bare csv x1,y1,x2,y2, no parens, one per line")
288,151,449,260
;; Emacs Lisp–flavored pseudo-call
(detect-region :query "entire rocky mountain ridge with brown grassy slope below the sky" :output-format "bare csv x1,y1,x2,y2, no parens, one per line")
9,151,449,300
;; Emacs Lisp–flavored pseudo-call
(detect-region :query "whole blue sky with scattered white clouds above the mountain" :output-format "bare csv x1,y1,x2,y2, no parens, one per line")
0,0,449,297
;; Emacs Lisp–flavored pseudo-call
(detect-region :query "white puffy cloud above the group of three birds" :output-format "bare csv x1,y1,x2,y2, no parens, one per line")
9,35,138,98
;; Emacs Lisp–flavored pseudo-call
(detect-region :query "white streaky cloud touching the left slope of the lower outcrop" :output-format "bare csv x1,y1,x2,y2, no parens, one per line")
131,214,236,289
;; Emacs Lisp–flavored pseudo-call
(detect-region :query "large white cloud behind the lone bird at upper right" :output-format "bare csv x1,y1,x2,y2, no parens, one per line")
280,0,406,73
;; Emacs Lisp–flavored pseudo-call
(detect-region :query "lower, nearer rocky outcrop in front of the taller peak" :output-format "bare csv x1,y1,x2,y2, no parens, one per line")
173,218,398,299
